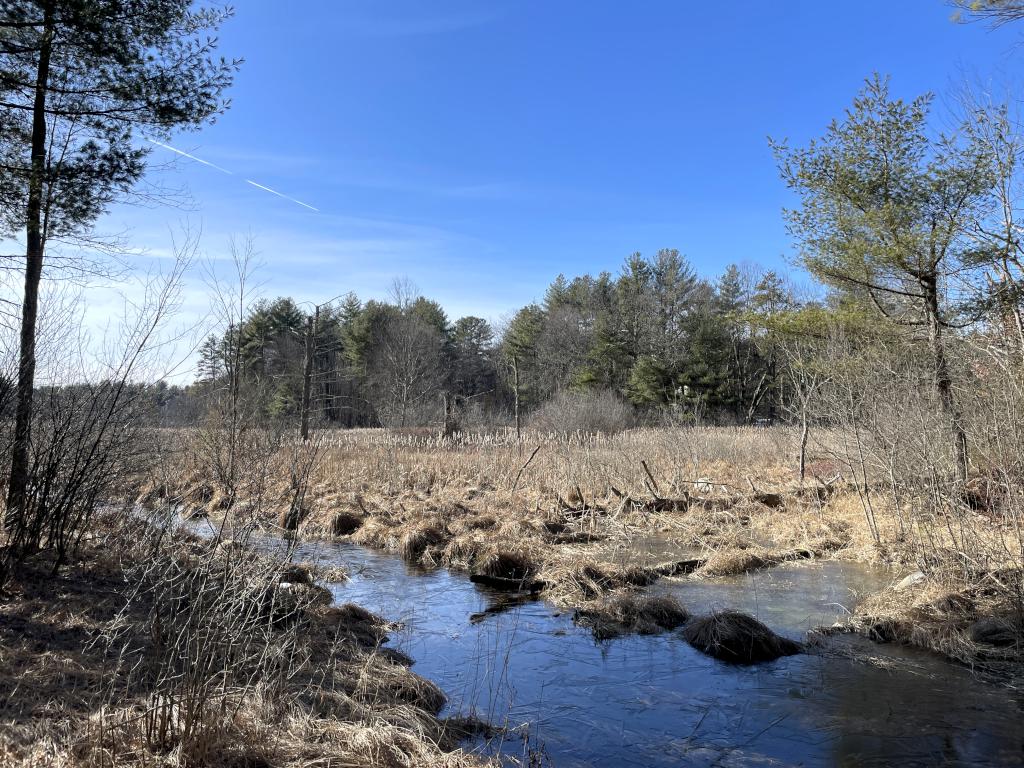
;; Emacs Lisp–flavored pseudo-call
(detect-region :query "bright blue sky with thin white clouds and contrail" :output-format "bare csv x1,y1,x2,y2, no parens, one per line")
102,0,1024,331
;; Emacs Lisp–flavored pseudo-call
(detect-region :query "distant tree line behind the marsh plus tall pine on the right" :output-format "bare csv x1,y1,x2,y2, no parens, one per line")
165,67,1024,505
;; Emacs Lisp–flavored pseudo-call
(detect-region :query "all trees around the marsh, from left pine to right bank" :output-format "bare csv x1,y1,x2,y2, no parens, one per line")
0,0,1024,586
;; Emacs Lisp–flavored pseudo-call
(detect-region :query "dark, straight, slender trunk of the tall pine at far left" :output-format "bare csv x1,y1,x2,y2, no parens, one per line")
5,3,53,529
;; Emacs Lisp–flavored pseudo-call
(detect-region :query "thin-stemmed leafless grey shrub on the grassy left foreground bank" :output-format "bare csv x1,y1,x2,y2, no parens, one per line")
97,531,313,764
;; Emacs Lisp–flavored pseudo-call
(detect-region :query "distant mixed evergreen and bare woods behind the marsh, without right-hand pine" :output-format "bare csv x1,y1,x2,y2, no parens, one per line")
180,249,804,431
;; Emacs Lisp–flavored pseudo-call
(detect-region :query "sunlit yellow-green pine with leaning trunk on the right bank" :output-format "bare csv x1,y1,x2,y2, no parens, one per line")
774,77,995,480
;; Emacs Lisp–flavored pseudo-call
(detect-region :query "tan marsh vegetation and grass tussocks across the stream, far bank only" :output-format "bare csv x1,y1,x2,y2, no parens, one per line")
137,427,1024,684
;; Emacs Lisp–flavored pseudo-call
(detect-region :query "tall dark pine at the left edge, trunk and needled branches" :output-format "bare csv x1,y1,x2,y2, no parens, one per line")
0,0,237,523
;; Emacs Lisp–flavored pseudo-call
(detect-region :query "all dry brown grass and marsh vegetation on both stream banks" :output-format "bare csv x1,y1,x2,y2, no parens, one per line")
0,427,1022,768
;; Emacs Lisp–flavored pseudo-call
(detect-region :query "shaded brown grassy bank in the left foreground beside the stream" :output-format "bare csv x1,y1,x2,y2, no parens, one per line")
0,520,491,768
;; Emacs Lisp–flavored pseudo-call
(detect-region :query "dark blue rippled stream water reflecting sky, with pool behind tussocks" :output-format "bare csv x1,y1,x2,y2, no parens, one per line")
282,545,1024,766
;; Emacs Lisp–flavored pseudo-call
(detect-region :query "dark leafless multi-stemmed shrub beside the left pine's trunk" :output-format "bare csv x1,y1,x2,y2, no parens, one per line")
0,249,191,586
